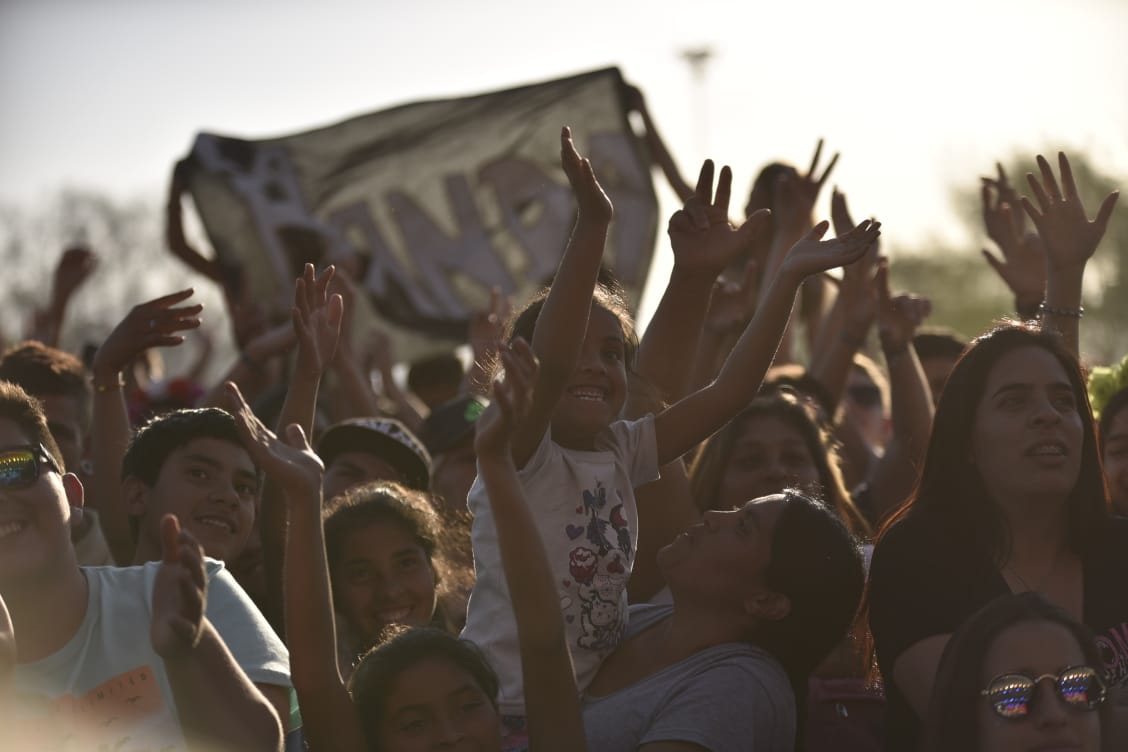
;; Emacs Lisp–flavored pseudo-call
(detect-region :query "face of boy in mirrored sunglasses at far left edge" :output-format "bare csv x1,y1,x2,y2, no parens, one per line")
0,418,82,592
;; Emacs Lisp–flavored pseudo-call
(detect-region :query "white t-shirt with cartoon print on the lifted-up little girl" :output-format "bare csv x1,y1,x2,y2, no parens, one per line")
461,415,659,715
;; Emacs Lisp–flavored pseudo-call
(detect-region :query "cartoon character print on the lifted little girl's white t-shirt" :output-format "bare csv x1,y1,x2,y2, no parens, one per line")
561,483,634,651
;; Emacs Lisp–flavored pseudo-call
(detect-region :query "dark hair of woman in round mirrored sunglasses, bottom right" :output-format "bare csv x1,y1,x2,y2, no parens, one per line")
924,593,1109,752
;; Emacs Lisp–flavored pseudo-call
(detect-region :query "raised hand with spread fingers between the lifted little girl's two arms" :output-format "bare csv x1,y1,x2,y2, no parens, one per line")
667,159,770,277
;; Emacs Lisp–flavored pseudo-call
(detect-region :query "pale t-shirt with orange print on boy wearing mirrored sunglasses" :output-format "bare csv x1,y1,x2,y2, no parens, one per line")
14,559,291,752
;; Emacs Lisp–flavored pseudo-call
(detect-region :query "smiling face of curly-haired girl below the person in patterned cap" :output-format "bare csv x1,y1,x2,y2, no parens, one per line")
333,521,437,647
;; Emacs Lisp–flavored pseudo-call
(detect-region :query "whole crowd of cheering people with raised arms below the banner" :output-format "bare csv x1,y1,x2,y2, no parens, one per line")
0,83,1128,752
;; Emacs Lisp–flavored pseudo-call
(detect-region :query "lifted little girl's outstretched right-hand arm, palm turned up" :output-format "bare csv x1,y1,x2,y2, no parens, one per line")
654,221,881,463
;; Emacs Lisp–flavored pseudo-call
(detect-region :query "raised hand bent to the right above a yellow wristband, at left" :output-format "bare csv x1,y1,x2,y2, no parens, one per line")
91,289,203,383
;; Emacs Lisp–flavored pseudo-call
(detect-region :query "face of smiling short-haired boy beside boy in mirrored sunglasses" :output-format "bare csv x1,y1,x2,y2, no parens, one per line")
123,437,258,561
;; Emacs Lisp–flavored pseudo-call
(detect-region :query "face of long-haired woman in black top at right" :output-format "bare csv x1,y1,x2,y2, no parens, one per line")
971,346,1083,508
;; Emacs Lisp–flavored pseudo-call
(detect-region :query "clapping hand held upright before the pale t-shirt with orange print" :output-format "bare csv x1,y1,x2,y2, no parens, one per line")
149,514,208,658
